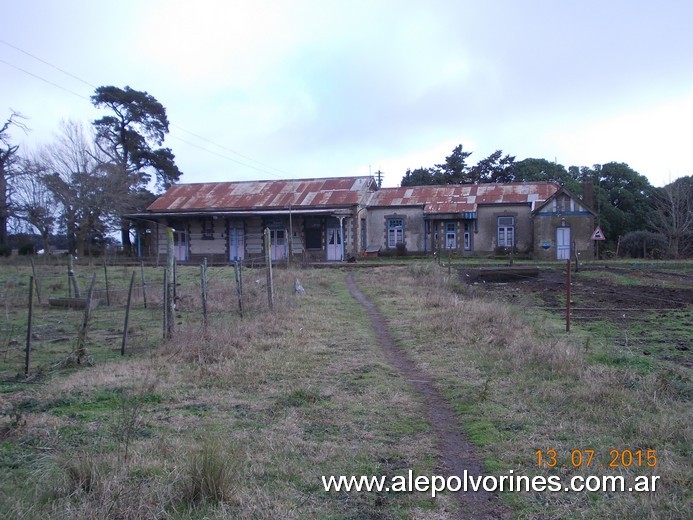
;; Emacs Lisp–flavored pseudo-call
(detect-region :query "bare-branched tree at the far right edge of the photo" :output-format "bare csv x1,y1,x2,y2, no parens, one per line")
649,175,693,258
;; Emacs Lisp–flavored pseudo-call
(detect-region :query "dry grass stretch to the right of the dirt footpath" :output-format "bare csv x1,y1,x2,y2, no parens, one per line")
359,264,693,518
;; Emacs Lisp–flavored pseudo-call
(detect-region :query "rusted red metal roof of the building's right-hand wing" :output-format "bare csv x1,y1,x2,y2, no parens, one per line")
369,182,559,213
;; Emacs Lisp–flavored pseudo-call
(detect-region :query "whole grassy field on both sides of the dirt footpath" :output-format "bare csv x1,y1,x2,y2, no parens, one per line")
0,261,693,519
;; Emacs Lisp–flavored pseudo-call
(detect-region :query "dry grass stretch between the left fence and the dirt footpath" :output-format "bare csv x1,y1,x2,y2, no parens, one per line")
0,270,450,519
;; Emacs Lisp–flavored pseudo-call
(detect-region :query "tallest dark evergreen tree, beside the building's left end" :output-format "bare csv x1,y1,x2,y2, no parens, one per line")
91,86,181,254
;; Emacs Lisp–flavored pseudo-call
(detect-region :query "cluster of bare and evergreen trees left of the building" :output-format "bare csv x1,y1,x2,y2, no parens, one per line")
0,86,181,256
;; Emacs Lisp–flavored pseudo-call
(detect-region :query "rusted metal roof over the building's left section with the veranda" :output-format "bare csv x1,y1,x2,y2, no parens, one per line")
147,177,373,212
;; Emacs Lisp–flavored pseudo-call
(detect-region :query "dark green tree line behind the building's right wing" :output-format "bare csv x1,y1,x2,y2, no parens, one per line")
401,144,693,258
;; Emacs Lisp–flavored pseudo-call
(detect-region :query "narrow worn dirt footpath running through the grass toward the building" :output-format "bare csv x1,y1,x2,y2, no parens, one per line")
346,273,511,519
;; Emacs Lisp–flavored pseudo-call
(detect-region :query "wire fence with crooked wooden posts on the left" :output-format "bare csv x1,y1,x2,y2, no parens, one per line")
0,259,278,382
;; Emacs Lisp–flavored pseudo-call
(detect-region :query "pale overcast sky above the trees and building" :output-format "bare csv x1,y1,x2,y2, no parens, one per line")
0,0,693,186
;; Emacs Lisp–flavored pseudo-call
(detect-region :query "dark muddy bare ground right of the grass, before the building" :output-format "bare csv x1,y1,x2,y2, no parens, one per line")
460,265,693,368
